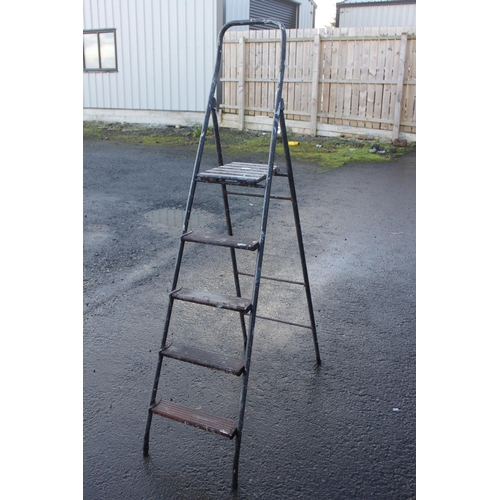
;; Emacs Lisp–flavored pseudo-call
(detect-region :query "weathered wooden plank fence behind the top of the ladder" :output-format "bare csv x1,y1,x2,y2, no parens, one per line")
219,27,416,140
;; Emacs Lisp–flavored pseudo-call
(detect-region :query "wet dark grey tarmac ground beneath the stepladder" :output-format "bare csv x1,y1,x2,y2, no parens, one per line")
83,140,416,500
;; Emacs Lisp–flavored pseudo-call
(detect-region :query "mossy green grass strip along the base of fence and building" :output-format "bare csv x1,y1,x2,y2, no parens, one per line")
83,122,416,168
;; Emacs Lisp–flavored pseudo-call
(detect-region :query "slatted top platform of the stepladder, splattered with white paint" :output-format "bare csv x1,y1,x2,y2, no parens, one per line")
196,162,279,186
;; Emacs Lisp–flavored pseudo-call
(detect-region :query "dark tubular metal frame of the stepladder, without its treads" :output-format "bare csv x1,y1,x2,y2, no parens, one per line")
143,19,321,489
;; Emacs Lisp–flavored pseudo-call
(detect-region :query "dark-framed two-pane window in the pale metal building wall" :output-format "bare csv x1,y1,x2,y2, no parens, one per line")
83,29,118,71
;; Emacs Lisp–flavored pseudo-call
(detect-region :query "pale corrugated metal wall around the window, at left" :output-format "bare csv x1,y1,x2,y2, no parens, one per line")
83,0,221,111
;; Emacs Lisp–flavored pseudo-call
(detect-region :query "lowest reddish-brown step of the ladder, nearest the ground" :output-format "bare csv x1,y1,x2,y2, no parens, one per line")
151,399,237,439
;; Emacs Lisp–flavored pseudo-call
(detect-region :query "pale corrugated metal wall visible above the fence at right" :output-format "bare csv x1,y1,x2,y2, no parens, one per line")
339,4,417,28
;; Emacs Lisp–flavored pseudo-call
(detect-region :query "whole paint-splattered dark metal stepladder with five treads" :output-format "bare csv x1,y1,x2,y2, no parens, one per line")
143,19,321,489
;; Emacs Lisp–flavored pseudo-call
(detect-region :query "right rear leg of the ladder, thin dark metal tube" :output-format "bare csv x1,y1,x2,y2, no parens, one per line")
280,101,321,365
